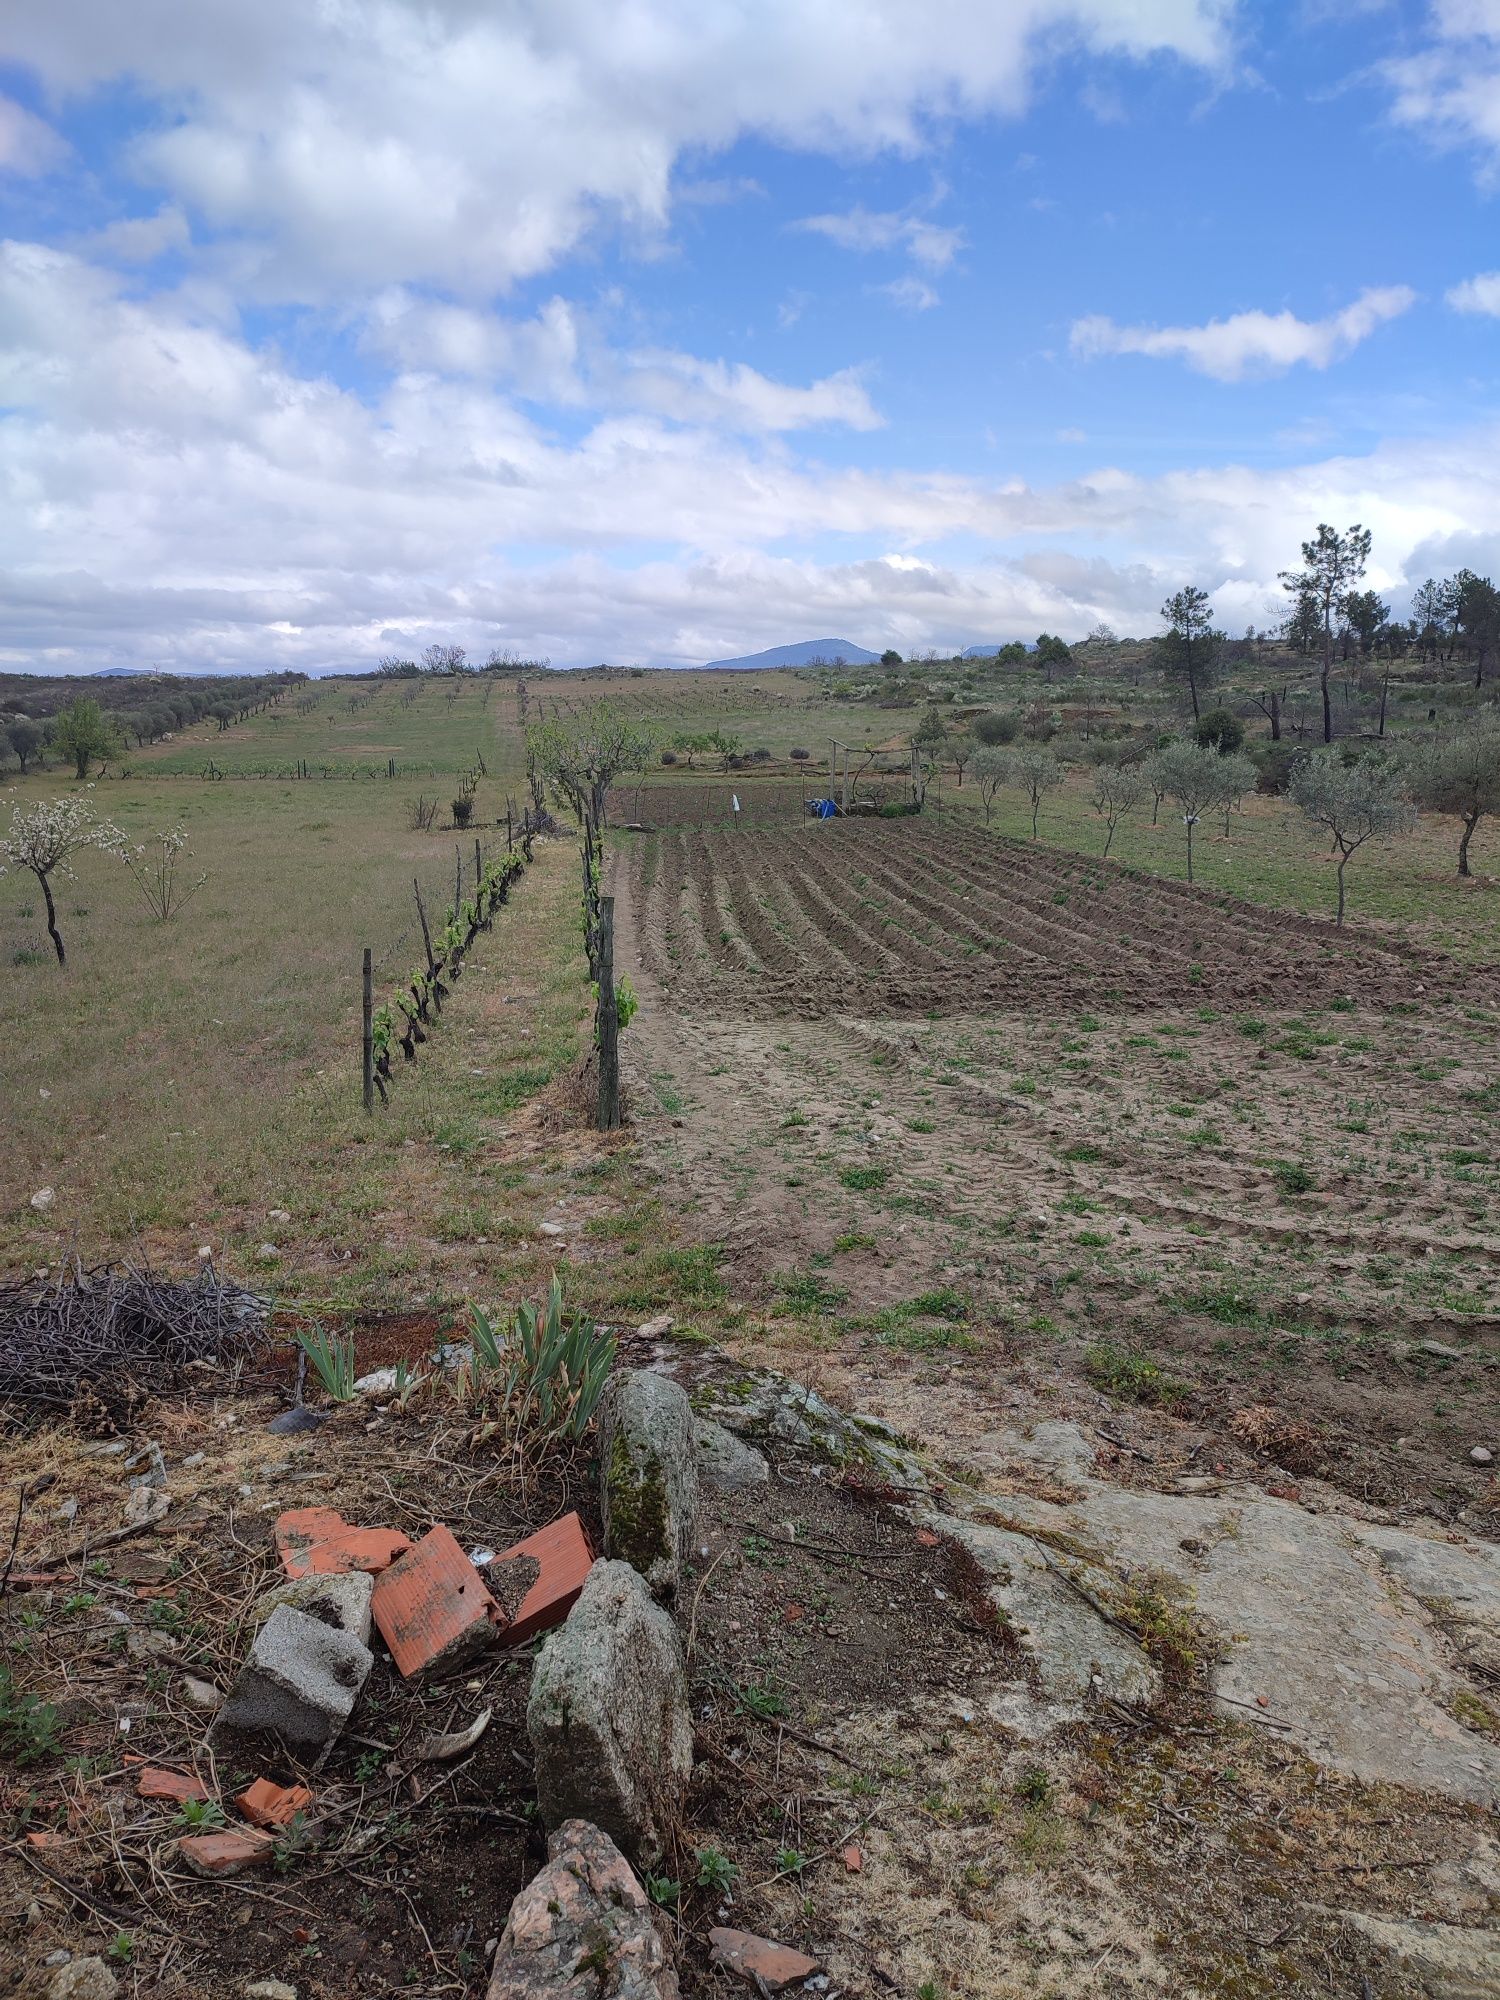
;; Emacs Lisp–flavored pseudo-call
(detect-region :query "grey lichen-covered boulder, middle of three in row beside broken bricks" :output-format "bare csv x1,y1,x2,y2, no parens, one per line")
526,1562,692,1862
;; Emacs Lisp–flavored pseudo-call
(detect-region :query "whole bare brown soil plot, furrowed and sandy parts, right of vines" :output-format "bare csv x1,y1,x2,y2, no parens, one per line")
622,826,1500,1534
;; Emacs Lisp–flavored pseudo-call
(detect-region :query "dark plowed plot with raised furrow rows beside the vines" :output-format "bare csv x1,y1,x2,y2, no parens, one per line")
626,820,1472,1018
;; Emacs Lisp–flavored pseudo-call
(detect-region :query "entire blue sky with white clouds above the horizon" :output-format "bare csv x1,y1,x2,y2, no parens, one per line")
0,0,1500,670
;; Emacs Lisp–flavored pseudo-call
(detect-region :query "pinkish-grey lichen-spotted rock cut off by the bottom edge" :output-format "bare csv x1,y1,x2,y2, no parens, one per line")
488,1820,678,2000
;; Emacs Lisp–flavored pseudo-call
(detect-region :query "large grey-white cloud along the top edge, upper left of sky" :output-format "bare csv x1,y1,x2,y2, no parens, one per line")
6,0,1228,302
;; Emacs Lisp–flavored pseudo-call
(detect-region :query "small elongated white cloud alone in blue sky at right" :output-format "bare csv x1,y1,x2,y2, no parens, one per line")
1068,284,1416,382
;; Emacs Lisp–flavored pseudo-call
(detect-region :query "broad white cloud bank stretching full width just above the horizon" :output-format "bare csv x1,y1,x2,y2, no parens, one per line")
0,244,1500,668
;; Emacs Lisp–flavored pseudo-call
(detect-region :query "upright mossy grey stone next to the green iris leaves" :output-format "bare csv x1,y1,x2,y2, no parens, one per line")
598,1368,698,1598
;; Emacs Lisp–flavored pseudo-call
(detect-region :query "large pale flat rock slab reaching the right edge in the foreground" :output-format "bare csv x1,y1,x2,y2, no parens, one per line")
948,1426,1500,1804
